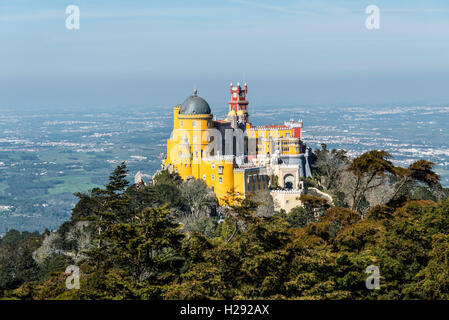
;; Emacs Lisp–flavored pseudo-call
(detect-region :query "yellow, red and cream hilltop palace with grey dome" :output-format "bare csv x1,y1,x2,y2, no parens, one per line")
163,83,311,211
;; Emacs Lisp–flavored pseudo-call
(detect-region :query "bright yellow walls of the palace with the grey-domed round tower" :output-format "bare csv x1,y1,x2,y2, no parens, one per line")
164,87,301,204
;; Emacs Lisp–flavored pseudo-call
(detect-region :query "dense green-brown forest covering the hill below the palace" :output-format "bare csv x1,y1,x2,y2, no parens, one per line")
0,145,449,299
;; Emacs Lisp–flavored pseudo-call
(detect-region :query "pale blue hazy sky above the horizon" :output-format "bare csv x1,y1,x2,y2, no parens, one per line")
0,0,449,110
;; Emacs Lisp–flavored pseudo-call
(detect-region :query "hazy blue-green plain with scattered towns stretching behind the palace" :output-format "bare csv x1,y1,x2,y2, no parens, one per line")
0,103,449,234
